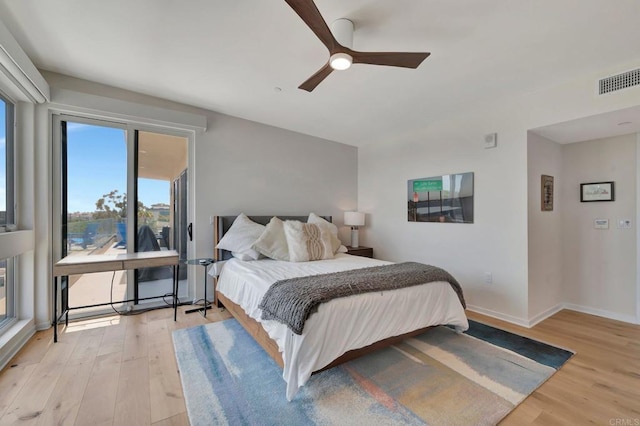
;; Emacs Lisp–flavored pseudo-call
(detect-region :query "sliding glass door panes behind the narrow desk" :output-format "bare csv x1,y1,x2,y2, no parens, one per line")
54,116,187,314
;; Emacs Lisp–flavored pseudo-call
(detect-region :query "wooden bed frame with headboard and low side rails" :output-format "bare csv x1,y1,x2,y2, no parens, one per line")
213,216,431,374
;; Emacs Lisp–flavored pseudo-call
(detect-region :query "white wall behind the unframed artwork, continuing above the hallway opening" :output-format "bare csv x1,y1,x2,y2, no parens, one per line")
358,60,640,325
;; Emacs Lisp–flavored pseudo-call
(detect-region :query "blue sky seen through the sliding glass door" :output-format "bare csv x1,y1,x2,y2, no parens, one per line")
67,122,170,213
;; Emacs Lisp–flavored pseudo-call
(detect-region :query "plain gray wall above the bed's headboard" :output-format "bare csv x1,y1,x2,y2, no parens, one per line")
194,110,358,256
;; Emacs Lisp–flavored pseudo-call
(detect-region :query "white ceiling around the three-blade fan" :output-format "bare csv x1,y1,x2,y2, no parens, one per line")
0,0,640,146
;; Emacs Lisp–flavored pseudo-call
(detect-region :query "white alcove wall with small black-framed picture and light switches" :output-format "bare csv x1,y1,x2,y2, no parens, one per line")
560,134,637,322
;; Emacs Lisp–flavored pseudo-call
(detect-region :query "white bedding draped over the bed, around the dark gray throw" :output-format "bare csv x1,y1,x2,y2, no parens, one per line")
212,253,469,400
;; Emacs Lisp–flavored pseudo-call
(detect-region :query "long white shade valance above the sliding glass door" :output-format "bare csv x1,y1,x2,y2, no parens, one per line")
50,87,207,131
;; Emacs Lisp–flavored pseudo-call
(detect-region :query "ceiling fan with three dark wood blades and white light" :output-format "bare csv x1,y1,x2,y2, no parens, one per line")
285,0,430,92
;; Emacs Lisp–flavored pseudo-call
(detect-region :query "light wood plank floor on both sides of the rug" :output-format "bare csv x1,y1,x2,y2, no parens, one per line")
0,308,640,426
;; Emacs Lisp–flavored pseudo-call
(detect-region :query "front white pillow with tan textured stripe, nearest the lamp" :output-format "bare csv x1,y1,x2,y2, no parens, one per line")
284,220,333,262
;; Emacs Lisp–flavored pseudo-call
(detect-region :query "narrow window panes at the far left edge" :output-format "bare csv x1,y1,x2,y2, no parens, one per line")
0,96,15,327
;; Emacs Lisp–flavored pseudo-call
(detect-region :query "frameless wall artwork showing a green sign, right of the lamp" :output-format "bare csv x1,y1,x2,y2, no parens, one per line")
407,172,473,223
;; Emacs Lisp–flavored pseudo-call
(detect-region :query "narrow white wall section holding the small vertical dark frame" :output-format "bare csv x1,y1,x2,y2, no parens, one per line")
527,132,565,322
